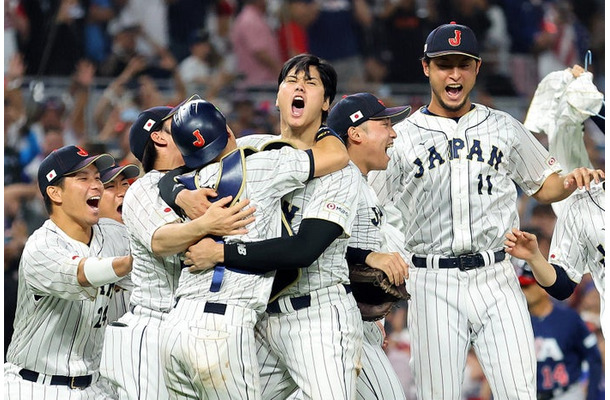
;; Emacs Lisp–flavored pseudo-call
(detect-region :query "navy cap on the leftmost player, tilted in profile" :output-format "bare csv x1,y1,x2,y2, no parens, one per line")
38,146,114,196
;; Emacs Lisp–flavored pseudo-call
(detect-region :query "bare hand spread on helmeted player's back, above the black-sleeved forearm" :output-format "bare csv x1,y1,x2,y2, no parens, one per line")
196,197,256,236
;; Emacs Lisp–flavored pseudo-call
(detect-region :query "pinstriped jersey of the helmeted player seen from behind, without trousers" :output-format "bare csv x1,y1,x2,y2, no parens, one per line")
176,147,310,312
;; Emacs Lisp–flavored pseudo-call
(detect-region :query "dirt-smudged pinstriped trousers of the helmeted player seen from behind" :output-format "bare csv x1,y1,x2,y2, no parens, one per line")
161,299,260,400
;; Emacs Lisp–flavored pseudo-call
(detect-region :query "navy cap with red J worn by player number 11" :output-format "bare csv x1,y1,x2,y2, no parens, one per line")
424,22,481,60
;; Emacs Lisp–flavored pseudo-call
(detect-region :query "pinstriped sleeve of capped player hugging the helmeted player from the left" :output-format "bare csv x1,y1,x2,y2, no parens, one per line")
123,174,181,253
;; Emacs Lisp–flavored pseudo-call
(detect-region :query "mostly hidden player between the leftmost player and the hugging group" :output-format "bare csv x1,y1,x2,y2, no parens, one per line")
99,164,140,323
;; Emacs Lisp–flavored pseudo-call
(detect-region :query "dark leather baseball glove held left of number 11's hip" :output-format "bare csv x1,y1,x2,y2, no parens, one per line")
349,264,411,321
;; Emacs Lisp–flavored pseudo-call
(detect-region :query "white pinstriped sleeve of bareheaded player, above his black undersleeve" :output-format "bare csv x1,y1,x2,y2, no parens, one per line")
303,162,360,236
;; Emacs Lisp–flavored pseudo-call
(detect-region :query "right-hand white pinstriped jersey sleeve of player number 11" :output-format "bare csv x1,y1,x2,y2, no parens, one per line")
506,116,561,196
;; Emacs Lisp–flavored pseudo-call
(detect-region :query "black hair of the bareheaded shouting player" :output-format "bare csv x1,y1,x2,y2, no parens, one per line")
277,53,337,122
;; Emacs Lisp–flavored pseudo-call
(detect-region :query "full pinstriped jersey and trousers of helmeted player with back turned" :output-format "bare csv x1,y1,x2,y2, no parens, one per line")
161,147,310,400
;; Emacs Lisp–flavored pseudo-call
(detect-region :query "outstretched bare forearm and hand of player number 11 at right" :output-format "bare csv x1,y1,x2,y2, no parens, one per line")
532,167,605,204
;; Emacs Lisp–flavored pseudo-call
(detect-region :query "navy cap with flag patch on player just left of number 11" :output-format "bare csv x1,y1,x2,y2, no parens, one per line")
326,93,411,139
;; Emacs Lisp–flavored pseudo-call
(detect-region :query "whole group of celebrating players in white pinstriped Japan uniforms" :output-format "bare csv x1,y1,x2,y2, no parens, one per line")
4,24,605,400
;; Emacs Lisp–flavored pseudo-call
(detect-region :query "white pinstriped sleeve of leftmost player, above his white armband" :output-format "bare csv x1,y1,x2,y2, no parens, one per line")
19,232,97,300
